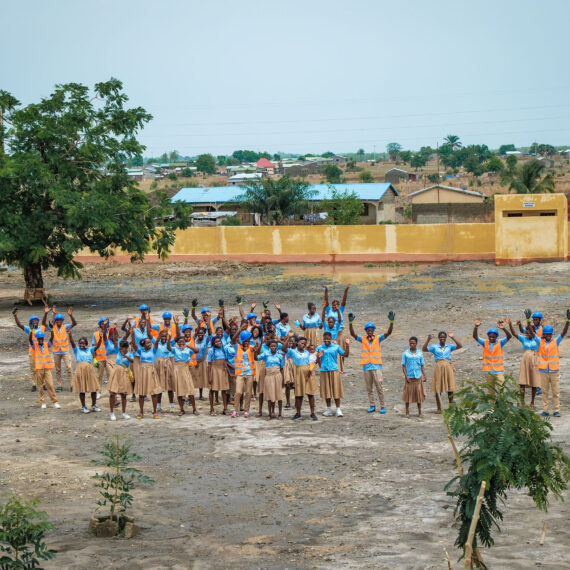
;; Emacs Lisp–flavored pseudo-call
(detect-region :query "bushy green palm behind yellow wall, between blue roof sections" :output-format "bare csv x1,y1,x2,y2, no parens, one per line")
236,176,315,225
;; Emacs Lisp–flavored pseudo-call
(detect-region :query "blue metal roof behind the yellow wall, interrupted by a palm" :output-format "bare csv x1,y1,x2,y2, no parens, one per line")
172,182,399,204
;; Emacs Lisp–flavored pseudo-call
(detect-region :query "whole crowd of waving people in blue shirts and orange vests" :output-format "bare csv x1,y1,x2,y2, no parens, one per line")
13,287,570,420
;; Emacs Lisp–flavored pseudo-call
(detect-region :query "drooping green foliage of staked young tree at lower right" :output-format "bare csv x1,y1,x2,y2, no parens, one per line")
444,376,570,548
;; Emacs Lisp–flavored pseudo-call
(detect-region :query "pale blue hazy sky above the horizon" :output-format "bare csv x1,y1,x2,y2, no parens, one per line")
0,0,570,155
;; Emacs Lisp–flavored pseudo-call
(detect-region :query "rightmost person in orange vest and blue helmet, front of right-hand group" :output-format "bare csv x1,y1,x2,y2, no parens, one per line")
538,309,570,418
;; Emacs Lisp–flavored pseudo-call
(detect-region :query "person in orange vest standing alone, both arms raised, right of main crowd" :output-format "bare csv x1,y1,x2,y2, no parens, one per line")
348,311,390,414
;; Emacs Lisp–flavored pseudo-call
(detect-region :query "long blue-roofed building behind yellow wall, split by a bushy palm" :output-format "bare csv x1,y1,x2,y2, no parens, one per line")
172,182,398,225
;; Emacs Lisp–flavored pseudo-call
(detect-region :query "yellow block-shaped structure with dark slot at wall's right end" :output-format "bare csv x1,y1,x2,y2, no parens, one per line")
495,194,568,263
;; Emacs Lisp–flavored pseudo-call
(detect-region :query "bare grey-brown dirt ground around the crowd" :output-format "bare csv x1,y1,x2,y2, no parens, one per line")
0,263,570,569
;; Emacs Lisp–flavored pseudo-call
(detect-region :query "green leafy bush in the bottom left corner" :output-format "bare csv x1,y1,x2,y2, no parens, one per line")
0,496,56,569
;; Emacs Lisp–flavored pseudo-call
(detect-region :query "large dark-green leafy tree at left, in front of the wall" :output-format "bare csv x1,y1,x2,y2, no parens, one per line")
0,79,190,290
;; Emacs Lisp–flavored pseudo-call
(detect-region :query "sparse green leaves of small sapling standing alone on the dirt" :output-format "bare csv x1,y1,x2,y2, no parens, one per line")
93,434,154,520
